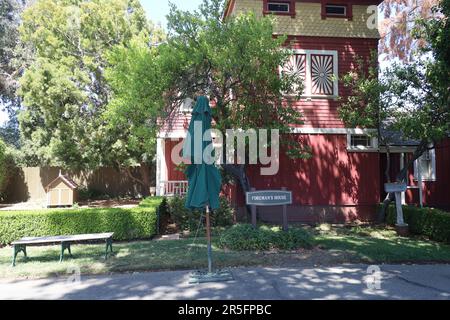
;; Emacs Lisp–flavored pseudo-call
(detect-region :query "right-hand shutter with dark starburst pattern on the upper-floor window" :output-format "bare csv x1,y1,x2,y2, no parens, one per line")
311,54,334,96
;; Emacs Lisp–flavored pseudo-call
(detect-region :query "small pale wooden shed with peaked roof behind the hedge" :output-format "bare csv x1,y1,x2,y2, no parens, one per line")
45,173,78,207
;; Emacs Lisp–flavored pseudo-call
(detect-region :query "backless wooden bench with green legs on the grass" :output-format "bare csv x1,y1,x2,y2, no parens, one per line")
11,232,114,267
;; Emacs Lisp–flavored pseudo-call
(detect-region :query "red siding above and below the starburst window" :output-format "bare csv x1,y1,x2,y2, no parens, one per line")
286,36,378,128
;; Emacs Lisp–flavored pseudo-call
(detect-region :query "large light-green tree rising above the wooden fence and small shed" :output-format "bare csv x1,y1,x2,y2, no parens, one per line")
19,0,162,195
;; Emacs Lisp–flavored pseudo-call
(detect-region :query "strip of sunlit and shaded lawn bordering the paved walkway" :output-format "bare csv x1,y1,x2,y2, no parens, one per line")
0,224,450,278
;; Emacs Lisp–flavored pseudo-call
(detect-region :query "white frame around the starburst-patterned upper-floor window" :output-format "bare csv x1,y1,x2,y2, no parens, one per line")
280,49,339,99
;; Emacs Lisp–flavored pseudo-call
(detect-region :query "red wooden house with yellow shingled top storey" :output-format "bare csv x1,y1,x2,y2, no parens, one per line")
156,0,450,222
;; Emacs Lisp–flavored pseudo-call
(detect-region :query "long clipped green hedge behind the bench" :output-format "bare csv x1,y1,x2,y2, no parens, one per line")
0,198,162,245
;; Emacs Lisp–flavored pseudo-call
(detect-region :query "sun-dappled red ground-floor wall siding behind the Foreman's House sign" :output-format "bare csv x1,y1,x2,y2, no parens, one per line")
243,135,380,205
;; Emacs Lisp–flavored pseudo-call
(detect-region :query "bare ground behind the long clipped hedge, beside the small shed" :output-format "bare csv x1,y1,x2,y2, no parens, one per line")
0,199,140,211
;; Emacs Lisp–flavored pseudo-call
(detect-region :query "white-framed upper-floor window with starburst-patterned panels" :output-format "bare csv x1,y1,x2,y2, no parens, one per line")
281,50,338,98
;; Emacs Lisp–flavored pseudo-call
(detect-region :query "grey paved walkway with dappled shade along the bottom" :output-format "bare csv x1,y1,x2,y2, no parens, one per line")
0,265,450,300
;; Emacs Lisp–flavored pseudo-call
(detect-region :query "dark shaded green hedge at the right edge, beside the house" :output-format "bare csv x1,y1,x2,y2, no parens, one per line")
387,205,450,243
